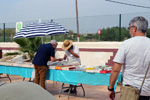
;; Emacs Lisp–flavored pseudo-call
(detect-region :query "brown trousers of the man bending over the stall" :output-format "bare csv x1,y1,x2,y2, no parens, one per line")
34,65,47,89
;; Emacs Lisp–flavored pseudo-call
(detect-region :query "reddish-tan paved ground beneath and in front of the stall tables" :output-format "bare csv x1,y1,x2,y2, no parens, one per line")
0,74,120,100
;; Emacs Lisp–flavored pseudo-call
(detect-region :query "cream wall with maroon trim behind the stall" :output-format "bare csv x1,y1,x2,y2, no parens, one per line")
0,42,121,66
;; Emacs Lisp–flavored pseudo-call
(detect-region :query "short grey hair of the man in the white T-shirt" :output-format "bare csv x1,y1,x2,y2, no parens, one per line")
129,16,148,33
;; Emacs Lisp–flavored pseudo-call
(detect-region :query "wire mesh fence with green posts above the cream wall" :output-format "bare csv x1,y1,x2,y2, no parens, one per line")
0,12,150,42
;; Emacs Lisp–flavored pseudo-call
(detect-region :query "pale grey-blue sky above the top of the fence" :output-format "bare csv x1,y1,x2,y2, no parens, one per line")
0,0,150,23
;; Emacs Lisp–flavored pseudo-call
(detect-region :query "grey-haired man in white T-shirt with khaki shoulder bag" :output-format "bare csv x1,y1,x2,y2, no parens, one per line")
108,16,150,100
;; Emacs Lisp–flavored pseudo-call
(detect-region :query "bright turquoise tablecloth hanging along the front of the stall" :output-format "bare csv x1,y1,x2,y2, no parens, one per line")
0,65,122,87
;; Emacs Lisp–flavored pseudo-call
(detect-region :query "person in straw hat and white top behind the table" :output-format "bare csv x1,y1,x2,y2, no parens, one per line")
62,40,81,93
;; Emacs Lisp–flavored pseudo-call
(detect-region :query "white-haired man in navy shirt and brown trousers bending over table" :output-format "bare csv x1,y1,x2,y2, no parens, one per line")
33,40,63,89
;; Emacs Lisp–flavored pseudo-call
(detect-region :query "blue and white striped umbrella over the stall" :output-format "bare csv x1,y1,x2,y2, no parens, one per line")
13,22,68,39
